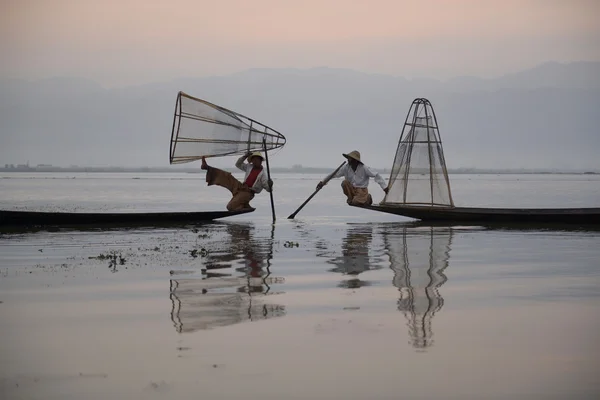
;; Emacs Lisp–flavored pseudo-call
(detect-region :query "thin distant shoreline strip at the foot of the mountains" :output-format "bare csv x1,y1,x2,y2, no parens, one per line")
0,166,600,175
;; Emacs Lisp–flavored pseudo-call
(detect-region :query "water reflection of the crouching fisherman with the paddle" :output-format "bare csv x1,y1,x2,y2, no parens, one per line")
328,224,381,289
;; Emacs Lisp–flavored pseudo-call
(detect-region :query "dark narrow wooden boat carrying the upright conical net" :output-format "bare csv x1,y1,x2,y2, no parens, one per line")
355,205,600,225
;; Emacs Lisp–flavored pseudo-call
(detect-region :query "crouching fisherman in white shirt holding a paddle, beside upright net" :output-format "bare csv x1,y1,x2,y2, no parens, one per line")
317,150,389,206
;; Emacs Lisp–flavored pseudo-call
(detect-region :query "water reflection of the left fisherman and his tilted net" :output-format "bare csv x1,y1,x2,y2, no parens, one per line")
170,224,286,333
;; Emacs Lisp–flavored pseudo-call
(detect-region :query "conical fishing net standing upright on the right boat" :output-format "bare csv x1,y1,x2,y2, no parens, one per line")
381,99,454,207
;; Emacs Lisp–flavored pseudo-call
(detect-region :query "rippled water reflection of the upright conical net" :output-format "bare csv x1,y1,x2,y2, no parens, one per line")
384,227,452,349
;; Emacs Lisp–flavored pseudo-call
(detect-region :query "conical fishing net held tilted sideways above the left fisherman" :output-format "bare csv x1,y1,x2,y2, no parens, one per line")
169,92,285,164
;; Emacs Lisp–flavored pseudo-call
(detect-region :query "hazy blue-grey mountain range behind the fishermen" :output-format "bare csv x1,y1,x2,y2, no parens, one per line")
0,62,600,170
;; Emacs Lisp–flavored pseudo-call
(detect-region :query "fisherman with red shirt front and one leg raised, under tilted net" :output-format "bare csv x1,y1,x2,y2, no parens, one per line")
200,152,273,211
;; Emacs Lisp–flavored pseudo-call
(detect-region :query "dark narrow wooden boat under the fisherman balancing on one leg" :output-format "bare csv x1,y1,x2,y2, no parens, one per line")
0,209,254,226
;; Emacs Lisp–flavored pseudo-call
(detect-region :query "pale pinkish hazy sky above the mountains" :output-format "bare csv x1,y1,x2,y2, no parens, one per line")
0,0,600,86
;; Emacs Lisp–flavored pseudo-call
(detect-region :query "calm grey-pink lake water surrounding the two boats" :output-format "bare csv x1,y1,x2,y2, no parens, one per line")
0,174,600,399
